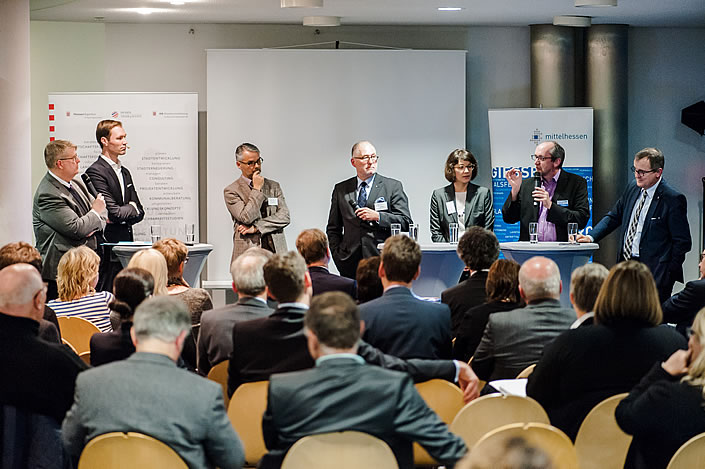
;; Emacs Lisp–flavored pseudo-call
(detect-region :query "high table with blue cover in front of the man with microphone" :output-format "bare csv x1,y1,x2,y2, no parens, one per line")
499,241,600,307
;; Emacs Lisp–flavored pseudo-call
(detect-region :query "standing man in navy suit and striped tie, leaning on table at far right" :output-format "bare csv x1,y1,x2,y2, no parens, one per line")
578,148,692,302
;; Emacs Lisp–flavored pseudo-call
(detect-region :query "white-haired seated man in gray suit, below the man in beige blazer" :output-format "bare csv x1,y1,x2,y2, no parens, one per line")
197,247,273,376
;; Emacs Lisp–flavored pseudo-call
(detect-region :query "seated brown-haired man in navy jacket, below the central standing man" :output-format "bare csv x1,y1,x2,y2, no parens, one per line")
360,235,452,359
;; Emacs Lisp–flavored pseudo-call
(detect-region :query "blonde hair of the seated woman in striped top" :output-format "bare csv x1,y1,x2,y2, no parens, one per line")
56,246,100,301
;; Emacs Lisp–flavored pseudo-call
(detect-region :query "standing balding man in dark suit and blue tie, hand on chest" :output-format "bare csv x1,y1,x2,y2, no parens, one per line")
326,141,411,278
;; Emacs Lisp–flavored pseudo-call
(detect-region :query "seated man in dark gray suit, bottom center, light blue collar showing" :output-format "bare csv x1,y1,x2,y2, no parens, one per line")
259,292,467,469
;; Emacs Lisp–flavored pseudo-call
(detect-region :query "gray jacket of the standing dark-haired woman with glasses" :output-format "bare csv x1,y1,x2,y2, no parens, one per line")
430,183,494,243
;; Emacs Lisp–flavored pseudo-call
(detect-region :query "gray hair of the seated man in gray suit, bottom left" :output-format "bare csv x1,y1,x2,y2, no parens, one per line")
132,296,191,342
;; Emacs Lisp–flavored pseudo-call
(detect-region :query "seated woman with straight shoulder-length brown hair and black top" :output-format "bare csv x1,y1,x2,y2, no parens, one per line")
526,261,686,439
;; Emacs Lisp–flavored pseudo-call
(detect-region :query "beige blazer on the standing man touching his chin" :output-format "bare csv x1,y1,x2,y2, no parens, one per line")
223,176,290,262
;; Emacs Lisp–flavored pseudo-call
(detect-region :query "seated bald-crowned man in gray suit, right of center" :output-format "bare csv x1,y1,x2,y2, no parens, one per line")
472,256,575,381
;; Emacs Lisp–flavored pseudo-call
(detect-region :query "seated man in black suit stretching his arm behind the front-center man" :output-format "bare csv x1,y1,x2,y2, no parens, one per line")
228,251,477,401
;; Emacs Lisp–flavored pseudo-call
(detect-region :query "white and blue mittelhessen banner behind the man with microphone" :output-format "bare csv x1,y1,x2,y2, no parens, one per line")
488,108,593,242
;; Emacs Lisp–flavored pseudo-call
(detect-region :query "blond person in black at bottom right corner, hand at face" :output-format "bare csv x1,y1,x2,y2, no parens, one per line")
615,308,705,469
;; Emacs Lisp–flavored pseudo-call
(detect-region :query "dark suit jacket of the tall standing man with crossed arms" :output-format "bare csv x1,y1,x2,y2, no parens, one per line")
86,156,144,243
